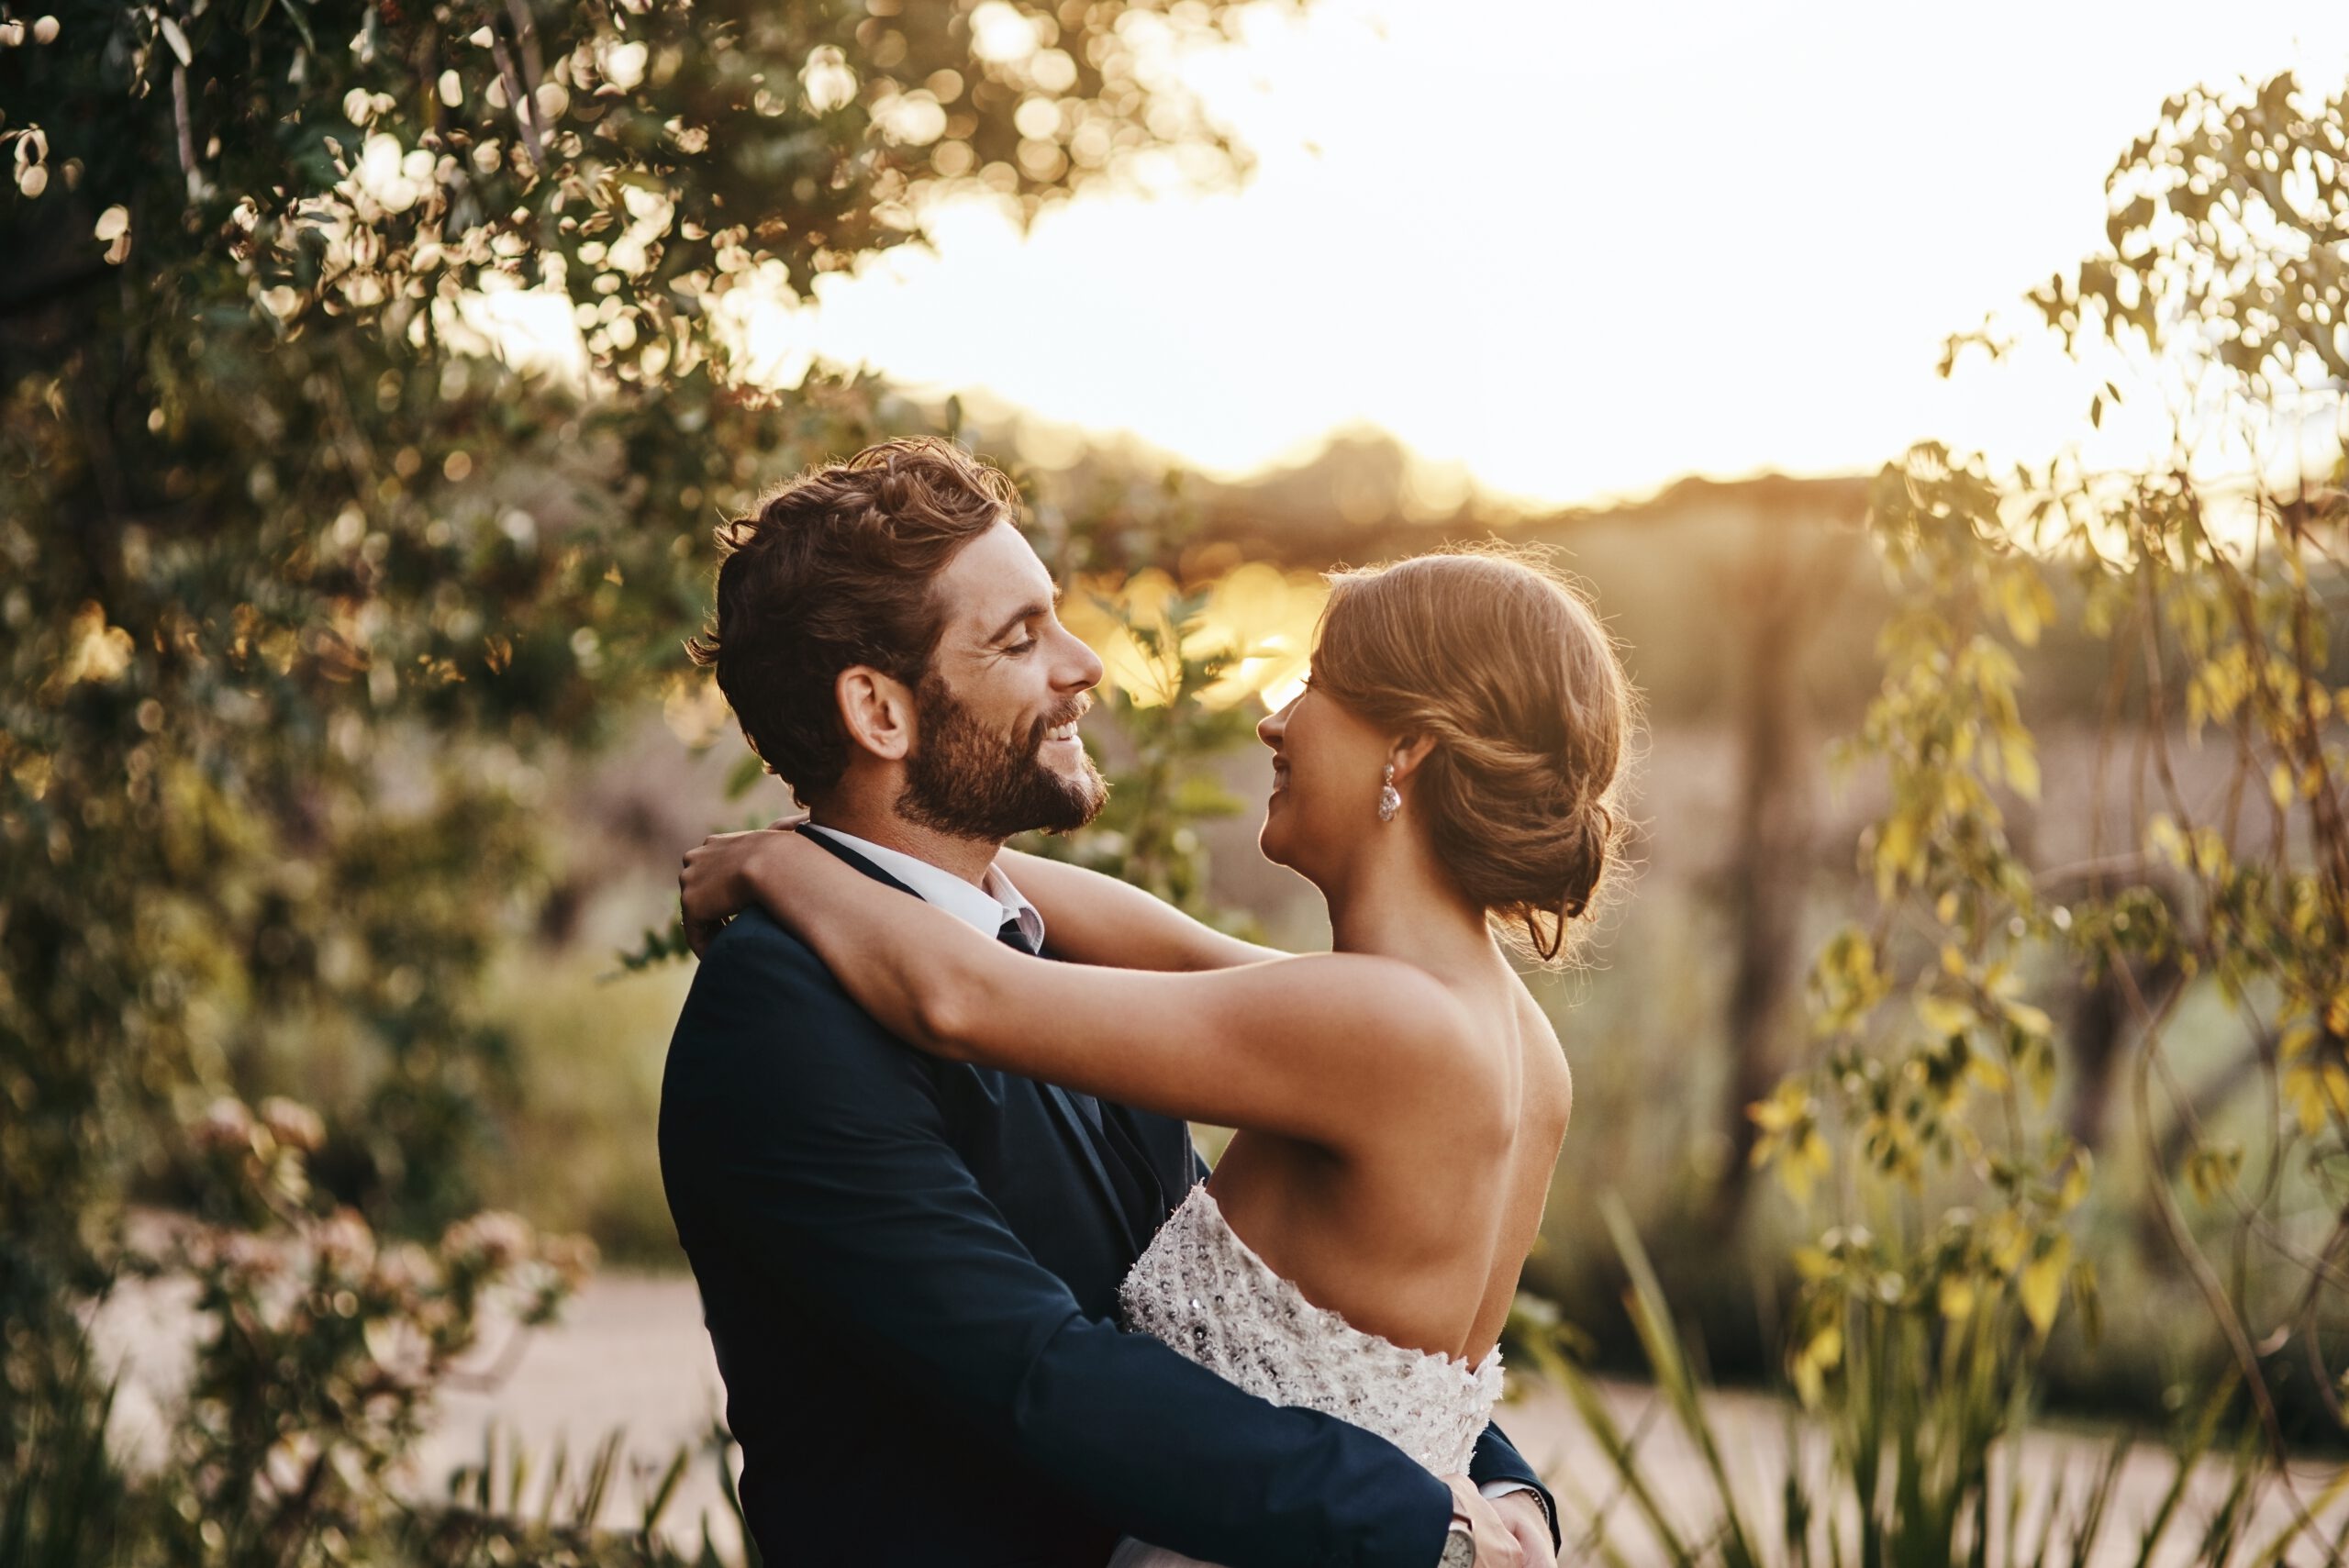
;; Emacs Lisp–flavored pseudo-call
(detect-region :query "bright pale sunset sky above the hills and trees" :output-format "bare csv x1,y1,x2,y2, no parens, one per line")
747,0,2349,500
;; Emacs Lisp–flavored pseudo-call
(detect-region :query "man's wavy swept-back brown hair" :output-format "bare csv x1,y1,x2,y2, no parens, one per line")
686,437,1019,800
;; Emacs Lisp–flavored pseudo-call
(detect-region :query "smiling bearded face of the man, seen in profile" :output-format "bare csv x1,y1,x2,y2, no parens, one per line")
897,521,1108,840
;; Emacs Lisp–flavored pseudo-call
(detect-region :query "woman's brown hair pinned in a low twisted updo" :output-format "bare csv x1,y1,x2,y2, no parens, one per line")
1313,545,1637,967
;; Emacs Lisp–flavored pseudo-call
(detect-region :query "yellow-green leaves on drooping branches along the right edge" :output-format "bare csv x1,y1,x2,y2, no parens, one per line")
1757,64,2349,1449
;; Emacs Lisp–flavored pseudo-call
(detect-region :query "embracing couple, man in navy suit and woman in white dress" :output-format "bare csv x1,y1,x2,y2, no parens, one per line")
660,441,1632,1568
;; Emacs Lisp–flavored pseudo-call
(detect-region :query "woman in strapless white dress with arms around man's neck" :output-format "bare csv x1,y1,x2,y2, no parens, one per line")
681,550,1632,1568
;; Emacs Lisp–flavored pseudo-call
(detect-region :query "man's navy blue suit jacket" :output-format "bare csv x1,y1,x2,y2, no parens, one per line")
660,836,1555,1568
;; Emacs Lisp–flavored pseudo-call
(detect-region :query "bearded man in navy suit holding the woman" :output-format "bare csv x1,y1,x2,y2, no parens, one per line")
660,441,1557,1568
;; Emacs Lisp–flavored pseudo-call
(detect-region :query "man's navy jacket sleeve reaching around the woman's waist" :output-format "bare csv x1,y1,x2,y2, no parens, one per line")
662,913,1482,1568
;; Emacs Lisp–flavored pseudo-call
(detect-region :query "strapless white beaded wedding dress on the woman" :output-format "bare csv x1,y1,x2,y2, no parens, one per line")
1108,1183,1501,1568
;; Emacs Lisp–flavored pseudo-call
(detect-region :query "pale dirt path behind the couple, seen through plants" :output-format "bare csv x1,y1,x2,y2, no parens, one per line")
86,1274,2349,1568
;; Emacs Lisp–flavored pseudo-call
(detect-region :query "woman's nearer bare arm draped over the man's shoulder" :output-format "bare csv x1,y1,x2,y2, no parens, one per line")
679,833,1506,1148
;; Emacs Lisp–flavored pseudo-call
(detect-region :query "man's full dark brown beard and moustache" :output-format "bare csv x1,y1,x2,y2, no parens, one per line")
897,672,1108,842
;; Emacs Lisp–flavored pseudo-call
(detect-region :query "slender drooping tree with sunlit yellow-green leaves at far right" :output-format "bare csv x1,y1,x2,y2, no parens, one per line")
1753,75,2349,1544
